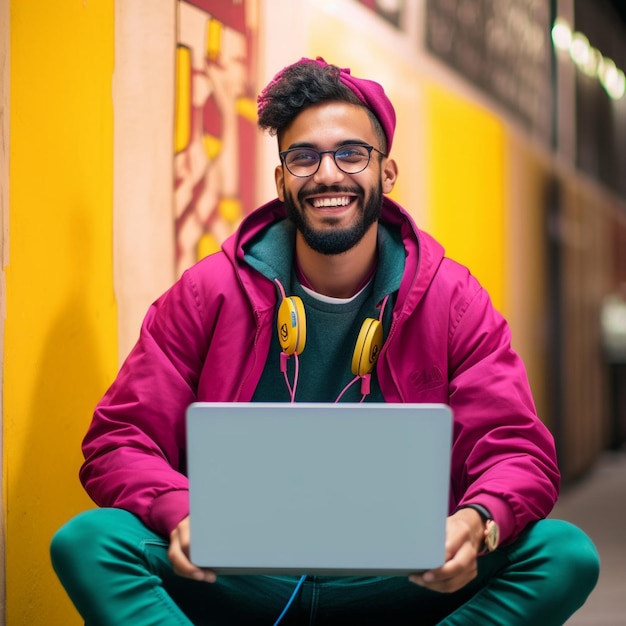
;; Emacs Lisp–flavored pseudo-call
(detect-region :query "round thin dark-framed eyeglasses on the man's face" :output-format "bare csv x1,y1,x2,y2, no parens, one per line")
278,144,387,178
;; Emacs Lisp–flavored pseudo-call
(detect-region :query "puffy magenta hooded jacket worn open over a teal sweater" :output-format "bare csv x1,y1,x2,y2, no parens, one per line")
80,198,559,541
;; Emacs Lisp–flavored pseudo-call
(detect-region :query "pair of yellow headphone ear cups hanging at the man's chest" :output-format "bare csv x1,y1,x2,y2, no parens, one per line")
277,296,383,376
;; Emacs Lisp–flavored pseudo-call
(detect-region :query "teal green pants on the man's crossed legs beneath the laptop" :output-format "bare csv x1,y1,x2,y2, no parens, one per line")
51,509,599,626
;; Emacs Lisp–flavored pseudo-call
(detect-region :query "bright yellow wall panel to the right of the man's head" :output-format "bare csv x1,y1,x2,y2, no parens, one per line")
424,83,509,315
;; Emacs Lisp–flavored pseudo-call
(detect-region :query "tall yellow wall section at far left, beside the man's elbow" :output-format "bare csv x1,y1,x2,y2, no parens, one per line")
3,0,117,626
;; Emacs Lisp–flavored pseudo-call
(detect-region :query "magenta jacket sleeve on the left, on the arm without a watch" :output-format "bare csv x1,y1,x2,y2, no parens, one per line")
80,275,208,537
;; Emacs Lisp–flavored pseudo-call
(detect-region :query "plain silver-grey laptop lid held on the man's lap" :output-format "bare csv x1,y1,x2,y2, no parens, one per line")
187,403,452,576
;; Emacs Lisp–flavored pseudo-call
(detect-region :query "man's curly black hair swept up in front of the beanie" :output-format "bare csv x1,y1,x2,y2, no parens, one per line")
258,62,387,152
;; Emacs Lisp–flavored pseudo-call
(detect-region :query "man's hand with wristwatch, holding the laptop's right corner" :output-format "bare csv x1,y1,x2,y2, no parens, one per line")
409,509,485,593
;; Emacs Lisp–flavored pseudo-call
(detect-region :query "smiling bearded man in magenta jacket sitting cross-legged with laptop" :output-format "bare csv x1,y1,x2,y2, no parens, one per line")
52,59,599,626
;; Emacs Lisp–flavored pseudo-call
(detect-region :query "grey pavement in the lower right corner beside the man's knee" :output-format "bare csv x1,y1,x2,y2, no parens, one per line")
550,451,626,626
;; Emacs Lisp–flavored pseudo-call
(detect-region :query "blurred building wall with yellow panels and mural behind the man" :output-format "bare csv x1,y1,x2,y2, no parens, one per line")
0,0,626,626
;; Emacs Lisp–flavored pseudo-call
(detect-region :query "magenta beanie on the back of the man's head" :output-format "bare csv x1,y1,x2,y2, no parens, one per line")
257,57,396,152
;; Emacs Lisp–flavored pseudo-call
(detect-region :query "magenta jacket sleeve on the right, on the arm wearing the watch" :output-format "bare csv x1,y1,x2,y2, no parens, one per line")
448,284,560,542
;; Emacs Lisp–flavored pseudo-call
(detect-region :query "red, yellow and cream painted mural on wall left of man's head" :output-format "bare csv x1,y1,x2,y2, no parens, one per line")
174,0,257,275
